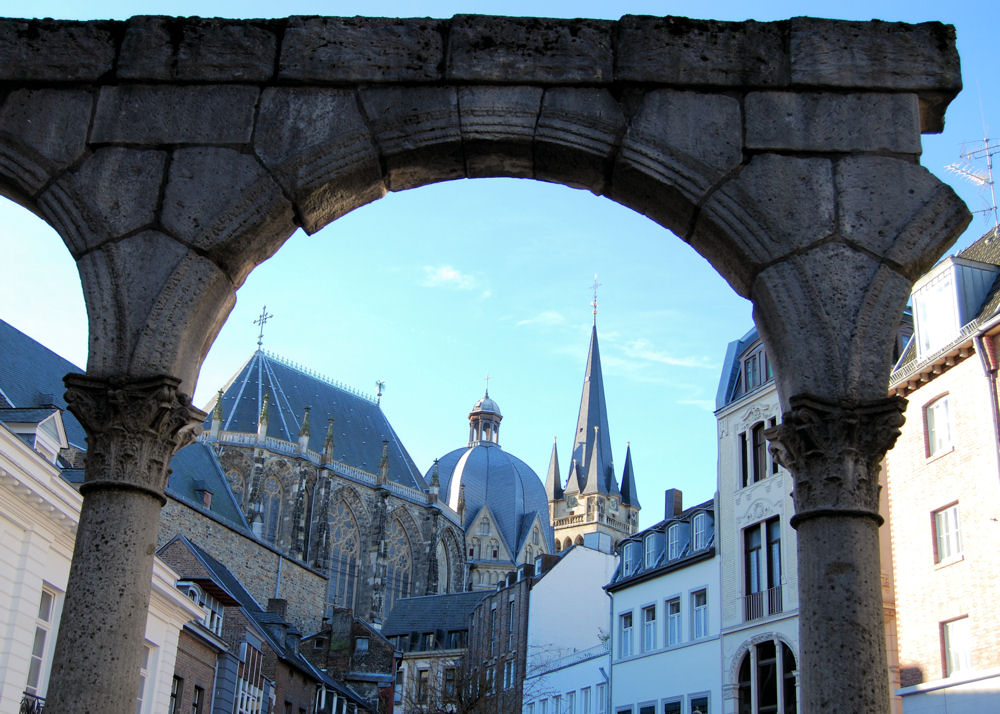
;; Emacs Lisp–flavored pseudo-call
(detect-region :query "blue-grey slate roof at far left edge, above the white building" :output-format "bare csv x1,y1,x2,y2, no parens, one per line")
0,320,87,450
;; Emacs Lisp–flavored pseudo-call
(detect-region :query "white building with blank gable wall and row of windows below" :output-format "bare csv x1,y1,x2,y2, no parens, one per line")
524,544,618,714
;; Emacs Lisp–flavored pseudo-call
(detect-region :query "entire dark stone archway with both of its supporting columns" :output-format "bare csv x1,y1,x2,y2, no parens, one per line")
0,16,969,714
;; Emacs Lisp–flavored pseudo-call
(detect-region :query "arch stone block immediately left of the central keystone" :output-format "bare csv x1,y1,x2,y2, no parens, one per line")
361,87,465,191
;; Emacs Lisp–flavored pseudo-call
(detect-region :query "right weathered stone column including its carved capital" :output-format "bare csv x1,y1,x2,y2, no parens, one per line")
765,395,906,713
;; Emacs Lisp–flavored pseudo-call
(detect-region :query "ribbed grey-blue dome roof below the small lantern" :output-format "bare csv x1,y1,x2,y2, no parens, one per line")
427,442,553,553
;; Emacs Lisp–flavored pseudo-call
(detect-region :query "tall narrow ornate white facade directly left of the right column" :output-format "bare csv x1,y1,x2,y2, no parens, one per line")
715,329,799,714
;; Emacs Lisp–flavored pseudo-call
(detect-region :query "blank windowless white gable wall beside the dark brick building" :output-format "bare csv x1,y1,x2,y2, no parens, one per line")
527,546,618,675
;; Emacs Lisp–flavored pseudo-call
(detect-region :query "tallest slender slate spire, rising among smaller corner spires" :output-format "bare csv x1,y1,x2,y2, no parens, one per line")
567,325,616,493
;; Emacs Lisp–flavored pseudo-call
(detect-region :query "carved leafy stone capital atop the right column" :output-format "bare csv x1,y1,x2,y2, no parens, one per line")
764,394,906,527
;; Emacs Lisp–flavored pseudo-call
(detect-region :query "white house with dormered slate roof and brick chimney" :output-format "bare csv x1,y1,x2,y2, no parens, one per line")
607,489,722,714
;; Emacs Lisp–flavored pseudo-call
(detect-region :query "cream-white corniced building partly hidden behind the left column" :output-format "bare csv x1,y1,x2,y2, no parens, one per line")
0,409,203,714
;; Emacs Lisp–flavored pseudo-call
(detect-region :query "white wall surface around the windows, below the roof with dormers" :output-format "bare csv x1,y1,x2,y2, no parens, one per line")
611,556,722,712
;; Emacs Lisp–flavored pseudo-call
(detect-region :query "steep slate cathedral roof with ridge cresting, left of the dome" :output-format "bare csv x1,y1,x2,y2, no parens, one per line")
205,350,427,491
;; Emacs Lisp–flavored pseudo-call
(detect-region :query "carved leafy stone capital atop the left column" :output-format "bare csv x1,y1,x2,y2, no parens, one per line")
63,374,206,503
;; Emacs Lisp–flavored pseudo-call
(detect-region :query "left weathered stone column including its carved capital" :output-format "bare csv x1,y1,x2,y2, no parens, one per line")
45,374,205,714
